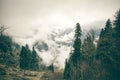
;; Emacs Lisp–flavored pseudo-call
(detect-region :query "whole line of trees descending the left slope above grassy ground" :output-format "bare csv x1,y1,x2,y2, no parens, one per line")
0,26,43,71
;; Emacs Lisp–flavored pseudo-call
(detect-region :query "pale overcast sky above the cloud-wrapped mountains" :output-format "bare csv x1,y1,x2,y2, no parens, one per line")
0,0,120,39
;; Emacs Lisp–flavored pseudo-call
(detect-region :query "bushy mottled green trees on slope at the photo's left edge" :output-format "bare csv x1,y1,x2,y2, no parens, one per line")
0,26,20,67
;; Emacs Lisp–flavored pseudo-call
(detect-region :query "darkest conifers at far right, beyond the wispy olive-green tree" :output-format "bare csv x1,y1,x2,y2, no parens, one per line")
95,15,120,80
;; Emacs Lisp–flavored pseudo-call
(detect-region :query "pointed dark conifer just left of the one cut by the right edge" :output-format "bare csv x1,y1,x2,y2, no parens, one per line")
97,19,114,80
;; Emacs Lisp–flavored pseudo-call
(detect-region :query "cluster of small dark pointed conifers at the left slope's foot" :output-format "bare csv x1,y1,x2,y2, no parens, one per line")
19,44,45,71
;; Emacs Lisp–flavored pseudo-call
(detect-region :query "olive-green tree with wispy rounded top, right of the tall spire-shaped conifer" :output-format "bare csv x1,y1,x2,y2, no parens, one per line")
81,30,96,80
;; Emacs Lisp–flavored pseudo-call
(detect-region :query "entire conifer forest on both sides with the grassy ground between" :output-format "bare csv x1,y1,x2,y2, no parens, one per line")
0,10,120,80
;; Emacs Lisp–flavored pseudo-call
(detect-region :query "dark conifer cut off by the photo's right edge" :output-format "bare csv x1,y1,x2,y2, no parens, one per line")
112,9,120,80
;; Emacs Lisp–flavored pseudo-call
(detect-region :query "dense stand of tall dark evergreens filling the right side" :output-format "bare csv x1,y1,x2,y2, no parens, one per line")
64,10,120,80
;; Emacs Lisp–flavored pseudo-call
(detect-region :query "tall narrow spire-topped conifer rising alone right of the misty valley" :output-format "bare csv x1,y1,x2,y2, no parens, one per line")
64,23,82,80
